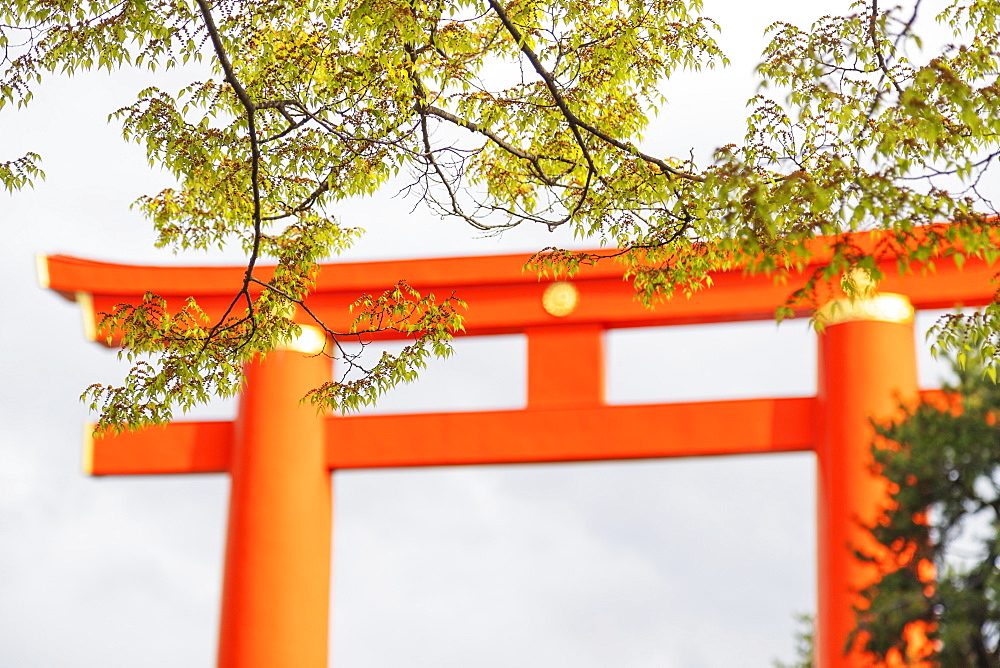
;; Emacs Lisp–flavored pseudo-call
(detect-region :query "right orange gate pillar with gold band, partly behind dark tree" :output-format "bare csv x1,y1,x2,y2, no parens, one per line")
816,294,918,668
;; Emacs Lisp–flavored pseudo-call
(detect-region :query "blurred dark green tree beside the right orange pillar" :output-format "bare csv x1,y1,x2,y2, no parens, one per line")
858,351,1000,668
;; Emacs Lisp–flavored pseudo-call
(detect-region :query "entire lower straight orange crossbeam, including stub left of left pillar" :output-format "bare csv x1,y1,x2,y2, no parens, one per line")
85,390,941,475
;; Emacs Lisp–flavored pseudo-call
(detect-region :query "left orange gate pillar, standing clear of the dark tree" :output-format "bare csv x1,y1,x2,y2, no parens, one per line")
219,327,332,668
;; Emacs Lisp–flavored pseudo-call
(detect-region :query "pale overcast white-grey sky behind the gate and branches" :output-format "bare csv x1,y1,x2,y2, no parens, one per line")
0,0,964,668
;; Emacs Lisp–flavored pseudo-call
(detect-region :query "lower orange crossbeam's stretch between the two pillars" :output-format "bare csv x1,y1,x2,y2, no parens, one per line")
327,398,815,470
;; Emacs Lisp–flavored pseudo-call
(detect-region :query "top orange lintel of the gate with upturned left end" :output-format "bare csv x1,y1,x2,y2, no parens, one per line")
38,228,997,340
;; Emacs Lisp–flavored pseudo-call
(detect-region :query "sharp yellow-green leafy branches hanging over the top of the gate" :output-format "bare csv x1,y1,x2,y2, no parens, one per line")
0,0,1000,426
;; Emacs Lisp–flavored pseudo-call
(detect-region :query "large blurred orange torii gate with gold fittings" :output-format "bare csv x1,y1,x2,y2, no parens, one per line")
39,235,996,668
